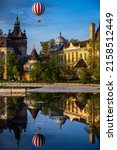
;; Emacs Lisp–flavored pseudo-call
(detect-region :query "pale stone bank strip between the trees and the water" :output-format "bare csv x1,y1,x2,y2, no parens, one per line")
0,83,100,93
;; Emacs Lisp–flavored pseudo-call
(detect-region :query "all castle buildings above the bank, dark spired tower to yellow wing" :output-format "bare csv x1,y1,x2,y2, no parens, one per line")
0,16,100,79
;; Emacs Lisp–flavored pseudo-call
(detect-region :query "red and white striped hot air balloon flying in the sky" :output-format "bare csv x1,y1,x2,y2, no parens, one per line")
32,2,45,16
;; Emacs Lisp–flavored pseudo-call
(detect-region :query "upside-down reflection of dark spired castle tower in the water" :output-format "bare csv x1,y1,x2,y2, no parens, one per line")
0,97,27,146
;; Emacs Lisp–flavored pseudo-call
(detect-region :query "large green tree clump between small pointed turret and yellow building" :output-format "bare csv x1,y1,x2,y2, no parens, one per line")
29,54,75,82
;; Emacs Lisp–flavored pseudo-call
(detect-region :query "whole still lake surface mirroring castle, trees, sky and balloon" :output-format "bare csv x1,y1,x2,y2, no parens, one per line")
0,93,100,150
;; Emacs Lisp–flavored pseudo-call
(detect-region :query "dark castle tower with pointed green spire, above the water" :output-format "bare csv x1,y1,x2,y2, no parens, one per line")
0,16,27,79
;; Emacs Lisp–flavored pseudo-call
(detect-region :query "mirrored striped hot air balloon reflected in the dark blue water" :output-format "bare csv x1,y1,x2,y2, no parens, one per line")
32,134,45,147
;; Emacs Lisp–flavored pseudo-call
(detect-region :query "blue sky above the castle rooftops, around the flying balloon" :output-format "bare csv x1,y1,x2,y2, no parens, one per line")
0,0,100,53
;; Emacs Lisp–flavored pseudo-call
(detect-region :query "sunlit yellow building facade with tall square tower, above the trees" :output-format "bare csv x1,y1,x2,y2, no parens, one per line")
60,23,100,66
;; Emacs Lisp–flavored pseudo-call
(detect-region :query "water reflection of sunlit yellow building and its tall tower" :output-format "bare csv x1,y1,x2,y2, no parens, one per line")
63,94,100,144
